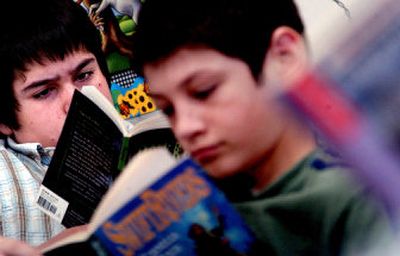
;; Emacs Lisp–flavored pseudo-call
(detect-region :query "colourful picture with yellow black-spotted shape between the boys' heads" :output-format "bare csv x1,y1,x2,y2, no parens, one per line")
77,0,156,119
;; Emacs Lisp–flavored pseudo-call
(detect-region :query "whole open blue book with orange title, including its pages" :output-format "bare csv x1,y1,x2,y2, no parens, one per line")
41,148,260,256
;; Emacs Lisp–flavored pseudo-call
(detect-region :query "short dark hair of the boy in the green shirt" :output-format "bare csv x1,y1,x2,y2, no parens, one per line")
133,0,304,78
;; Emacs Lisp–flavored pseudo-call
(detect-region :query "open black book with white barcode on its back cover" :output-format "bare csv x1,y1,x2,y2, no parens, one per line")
37,86,182,227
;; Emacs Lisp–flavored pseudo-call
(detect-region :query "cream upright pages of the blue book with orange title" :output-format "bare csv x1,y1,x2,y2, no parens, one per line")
89,148,177,233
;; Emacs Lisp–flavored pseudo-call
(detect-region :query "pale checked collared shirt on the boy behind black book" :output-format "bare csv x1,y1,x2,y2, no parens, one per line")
0,138,64,245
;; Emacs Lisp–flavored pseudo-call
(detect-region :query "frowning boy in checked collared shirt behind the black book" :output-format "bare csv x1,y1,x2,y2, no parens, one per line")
0,0,111,245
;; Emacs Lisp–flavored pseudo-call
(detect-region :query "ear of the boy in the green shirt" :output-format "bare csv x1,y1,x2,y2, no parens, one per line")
263,26,309,85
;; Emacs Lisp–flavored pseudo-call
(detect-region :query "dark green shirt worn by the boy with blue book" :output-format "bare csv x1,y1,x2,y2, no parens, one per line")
231,151,392,255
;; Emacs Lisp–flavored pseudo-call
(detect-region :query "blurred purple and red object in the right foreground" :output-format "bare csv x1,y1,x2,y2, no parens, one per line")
284,0,400,228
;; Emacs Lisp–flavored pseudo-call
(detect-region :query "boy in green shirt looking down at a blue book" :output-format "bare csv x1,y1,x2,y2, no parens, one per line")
134,0,396,255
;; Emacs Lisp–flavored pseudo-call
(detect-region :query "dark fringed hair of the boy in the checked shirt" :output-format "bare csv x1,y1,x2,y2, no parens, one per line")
0,0,108,129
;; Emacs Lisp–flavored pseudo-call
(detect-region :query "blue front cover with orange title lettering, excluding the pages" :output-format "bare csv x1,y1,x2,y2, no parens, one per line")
91,159,254,256
